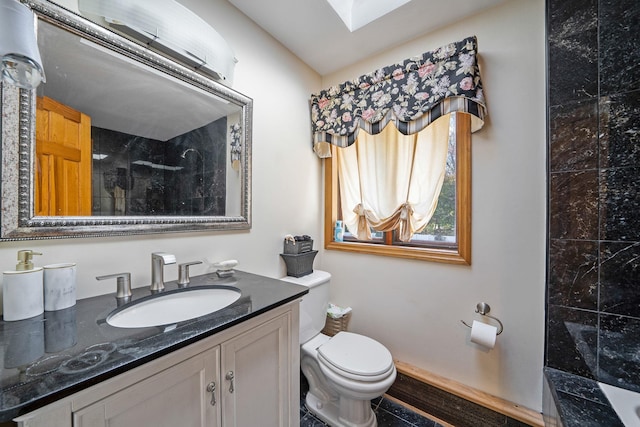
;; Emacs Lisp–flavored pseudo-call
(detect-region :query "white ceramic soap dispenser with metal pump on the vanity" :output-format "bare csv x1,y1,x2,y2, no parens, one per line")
2,250,44,321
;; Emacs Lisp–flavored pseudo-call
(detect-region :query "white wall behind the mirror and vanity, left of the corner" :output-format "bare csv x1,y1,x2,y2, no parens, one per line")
0,0,322,298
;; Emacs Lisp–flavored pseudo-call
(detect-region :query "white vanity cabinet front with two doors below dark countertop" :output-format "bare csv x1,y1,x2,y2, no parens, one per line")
15,301,300,427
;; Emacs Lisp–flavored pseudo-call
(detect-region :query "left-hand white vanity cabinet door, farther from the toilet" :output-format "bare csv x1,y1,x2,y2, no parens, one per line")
73,346,220,427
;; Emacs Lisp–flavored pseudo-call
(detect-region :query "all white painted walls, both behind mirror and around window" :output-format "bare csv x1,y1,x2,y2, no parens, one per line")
0,0,546,410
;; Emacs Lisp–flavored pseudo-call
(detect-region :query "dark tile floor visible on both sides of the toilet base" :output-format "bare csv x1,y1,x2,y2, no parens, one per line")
300,373,443,427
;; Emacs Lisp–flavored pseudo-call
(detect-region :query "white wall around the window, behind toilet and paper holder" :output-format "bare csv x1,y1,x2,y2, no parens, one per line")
322,0,546,410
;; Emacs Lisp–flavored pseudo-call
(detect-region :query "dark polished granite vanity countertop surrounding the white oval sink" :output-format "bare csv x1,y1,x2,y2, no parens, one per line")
0,271,308,422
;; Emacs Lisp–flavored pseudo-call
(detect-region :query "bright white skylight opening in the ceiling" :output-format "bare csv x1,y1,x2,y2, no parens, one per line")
327,0,411,32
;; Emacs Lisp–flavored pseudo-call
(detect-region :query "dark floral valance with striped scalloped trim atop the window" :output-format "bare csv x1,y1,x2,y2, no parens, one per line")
311,36,486,157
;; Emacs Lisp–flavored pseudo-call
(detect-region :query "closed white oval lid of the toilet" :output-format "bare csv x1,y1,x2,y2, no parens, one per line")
318,332,393,376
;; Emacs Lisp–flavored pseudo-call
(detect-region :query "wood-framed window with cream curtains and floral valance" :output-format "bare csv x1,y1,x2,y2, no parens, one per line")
310,37,486,265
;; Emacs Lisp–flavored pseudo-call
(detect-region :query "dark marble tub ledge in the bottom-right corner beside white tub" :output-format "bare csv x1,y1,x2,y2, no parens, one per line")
544,367,624,427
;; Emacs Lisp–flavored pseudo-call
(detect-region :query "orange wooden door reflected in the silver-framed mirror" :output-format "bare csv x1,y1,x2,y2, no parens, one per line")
35,97,92,216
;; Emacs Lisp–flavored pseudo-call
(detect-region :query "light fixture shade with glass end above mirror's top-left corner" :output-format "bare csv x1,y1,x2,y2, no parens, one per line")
0,0,45,89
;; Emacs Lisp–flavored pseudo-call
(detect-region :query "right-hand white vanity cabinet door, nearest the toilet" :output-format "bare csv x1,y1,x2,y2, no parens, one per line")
221,313,292,427
